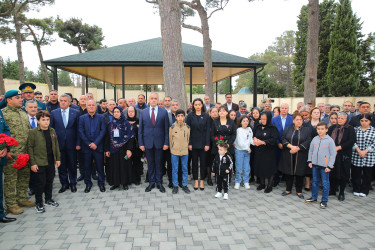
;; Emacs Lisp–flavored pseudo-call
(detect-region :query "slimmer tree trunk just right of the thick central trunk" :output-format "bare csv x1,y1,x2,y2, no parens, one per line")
197,1,214,102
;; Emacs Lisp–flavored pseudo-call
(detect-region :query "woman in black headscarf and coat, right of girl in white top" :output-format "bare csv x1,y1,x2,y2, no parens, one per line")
253,111,279,193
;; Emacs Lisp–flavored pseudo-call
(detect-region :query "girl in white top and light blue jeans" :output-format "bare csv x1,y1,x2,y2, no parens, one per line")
234,115,253,189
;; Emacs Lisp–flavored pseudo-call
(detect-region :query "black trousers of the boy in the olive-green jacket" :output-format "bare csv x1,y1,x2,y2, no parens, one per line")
35,165,55,204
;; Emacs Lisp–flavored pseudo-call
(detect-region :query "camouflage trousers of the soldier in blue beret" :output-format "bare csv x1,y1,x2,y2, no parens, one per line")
3,160,30,208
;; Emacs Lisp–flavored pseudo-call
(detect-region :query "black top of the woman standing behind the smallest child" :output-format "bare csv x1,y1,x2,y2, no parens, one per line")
211,118,237,156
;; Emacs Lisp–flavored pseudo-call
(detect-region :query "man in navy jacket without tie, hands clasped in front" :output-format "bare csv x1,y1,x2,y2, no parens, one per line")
79,100,106,193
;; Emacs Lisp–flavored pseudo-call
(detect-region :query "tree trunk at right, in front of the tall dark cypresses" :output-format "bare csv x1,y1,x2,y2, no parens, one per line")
304,0,320,106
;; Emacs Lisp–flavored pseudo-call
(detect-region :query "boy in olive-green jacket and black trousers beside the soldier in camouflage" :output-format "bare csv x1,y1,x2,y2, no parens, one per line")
27,110,61,213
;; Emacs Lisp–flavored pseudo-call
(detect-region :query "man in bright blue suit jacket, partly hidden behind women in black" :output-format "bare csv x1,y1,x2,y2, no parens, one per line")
272,103,293,187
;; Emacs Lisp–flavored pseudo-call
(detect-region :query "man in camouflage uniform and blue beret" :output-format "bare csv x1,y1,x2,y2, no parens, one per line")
0,90,35,214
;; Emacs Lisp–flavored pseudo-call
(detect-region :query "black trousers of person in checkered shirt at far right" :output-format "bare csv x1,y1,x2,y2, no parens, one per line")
352,165,373,195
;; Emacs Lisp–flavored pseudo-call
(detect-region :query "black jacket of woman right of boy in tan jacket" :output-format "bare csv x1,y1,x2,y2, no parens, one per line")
185,112,211,149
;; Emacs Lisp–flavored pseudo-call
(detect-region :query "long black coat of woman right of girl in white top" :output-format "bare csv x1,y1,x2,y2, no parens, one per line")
253,124,279,178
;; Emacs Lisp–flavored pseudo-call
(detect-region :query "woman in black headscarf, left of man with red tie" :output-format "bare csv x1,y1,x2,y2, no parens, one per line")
125,106,143,186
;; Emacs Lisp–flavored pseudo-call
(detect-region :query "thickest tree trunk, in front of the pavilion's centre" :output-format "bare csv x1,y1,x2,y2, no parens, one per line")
158,0,187,110
